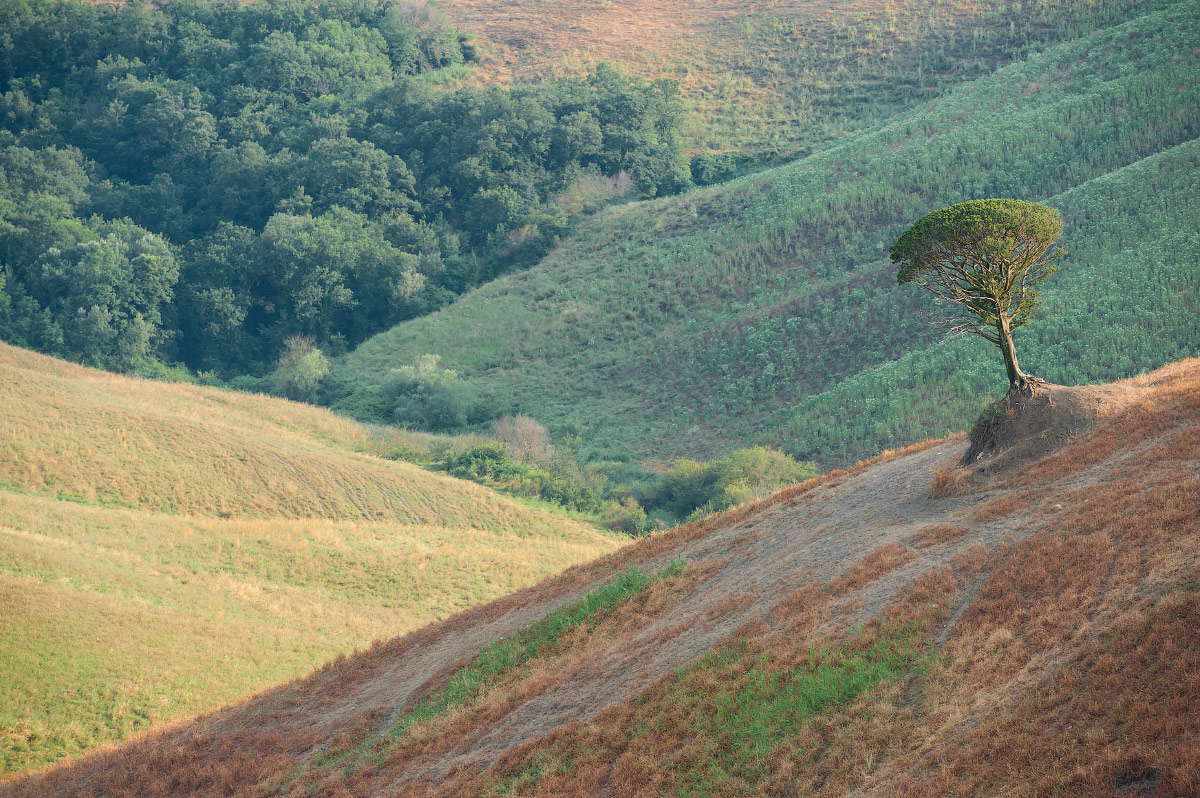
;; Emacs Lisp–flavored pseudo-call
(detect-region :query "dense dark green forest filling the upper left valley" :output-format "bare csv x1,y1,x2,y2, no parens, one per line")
0,0,690,379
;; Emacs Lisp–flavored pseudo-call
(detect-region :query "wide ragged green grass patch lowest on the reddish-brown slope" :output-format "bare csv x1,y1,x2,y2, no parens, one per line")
485,618,928,798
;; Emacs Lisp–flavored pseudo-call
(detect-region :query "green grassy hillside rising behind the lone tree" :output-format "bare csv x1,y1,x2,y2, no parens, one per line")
337,2,1200,464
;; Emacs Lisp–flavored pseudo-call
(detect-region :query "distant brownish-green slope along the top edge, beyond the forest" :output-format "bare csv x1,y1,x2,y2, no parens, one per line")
440,0,1152,152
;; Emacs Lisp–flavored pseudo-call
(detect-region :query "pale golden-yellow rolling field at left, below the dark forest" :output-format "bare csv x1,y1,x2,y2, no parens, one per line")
0,346,620,779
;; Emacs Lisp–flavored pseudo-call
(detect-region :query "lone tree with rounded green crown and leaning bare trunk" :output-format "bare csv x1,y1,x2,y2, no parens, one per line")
889,199,1064,390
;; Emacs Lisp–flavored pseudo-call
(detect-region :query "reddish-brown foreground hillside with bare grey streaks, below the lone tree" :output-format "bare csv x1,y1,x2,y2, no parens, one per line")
0,360,1200,797
